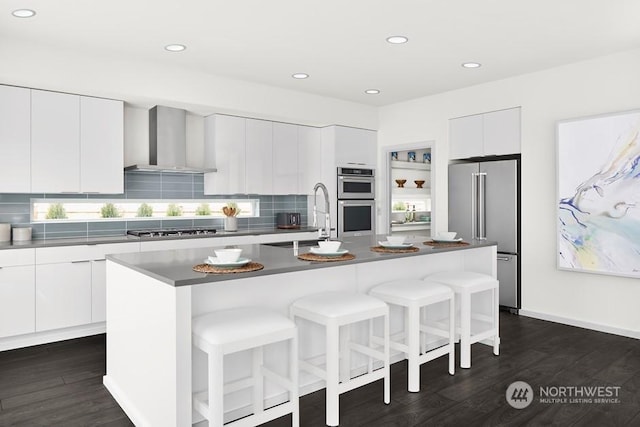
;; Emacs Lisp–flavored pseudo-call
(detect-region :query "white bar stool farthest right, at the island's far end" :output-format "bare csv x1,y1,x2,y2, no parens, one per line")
424,271,500,368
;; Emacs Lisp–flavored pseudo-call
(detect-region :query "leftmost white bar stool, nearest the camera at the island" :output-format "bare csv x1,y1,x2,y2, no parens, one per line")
192,307,300,427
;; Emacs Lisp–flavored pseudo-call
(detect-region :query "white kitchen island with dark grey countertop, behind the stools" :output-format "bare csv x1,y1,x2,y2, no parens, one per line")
104,236,496,427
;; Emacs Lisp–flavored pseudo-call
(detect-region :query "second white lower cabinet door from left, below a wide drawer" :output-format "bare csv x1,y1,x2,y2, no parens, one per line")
36,261,91,332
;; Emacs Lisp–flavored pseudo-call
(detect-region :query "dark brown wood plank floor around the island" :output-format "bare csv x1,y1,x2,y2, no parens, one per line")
0,313,640,427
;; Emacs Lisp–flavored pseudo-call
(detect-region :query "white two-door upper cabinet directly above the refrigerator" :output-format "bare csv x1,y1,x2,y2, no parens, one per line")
449,107,520,159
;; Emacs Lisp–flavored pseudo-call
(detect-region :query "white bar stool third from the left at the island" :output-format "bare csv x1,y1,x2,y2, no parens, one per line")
369,279,455,392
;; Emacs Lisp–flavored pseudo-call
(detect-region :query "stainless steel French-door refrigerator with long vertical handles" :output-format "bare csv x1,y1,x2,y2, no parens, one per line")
449,158,521,310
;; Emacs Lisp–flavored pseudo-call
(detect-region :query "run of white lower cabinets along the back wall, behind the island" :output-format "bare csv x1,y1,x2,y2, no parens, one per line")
0,236,317,350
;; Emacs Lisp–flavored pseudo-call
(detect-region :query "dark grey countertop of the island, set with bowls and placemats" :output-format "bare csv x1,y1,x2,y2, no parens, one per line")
107,235,496,286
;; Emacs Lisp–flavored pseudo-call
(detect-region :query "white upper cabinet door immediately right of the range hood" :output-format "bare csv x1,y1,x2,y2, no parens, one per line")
204,114,246,194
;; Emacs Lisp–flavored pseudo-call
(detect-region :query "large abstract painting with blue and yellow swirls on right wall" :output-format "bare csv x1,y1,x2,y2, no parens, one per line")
556,111,640,277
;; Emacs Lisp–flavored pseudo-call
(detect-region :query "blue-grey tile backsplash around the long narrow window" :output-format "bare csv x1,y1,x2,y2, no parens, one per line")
0,171,308,239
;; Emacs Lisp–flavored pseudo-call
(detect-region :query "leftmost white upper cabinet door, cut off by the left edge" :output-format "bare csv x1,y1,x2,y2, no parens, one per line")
0,86,31,193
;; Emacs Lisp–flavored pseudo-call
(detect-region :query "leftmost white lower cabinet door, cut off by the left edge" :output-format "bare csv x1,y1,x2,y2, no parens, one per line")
0,265,36,337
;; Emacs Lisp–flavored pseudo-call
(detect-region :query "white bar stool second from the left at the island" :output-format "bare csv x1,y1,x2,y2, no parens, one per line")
290,292,391,426
